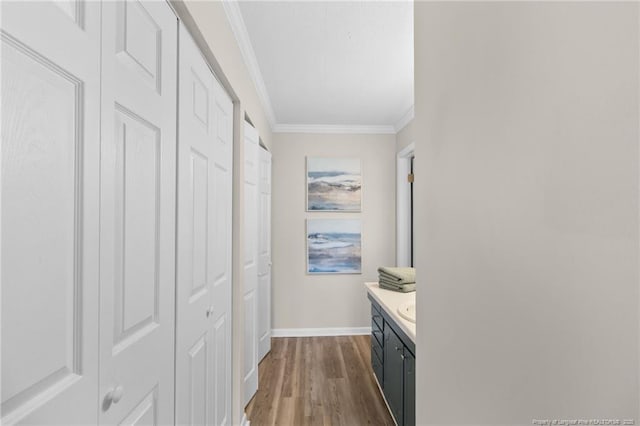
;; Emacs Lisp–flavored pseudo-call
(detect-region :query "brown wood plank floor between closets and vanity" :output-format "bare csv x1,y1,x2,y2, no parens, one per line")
246,336,394,426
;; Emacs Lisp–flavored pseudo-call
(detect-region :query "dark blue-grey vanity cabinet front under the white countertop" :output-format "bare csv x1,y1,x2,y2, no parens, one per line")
369,296,416,426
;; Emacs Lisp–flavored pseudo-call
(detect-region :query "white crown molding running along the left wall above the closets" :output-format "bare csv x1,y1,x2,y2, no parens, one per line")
222,0,276,130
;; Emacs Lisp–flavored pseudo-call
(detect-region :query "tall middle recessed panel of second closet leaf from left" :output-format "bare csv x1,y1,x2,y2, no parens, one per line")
113,106,160,342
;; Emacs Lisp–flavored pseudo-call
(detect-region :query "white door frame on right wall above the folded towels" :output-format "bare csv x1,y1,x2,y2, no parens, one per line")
396,142,415,266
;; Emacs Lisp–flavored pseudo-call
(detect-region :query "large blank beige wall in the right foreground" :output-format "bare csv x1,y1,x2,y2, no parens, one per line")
414,2,640,425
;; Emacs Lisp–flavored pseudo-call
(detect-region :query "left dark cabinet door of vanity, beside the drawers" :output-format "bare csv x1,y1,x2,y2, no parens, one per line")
384,326,404,425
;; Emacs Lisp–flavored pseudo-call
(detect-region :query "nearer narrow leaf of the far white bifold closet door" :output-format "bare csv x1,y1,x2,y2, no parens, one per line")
242,122,258,404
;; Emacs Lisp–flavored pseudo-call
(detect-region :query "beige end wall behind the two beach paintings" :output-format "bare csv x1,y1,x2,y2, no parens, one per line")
272,133,395,329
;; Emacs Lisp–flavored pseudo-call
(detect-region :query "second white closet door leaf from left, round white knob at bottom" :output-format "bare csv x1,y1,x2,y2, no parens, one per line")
99,0,177,424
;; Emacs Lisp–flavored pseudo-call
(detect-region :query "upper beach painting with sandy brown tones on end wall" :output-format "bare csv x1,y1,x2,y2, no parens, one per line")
307,157,362,212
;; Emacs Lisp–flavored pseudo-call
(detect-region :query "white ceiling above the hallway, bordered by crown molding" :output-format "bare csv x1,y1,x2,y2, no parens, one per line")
232,1,413,133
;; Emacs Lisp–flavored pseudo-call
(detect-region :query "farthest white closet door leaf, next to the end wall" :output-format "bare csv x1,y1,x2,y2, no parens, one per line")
258,148,271,360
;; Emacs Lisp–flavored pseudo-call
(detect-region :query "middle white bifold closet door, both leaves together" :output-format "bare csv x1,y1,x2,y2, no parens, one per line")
176,26,233,425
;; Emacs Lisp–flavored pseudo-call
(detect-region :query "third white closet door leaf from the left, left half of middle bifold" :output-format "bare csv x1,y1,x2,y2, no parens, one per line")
176,25,215,425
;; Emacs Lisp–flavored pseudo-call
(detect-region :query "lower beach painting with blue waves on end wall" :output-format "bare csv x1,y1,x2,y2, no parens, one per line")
307,219,362,274
